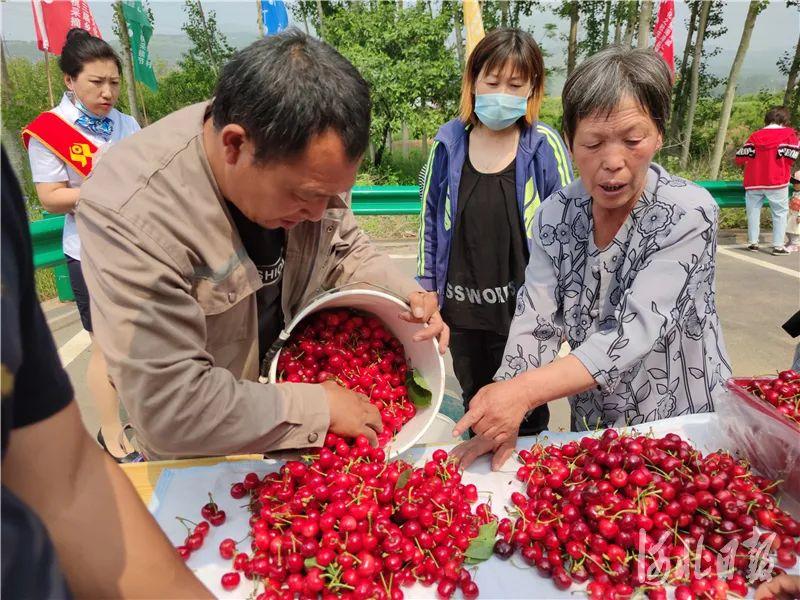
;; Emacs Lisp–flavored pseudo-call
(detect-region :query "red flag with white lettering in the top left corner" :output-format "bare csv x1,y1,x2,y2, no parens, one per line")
31,0,102,55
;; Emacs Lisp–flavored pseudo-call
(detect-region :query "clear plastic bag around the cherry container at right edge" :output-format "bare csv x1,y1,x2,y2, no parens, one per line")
715,377,800,502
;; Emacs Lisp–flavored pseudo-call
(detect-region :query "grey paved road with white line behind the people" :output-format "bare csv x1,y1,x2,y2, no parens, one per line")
44,237,800,440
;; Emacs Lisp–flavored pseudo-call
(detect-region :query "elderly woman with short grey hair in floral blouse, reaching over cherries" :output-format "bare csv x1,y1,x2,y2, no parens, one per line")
454,47,730,469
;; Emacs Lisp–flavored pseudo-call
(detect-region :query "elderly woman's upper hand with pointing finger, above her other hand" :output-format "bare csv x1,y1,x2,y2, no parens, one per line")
453,379,535,443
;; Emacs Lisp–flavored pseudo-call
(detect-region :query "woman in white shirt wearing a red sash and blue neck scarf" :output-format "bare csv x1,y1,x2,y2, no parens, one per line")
22,29,140,462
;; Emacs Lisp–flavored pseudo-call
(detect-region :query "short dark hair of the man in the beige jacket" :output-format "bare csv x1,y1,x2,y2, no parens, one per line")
211,28,372,163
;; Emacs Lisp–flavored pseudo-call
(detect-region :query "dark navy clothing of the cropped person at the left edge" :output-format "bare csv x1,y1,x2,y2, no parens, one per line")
0,150,72,598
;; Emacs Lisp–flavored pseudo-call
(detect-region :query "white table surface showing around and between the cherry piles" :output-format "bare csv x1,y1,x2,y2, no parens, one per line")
150,414,800,600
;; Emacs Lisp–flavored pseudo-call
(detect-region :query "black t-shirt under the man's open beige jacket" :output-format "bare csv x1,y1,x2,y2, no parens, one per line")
227,202,286,357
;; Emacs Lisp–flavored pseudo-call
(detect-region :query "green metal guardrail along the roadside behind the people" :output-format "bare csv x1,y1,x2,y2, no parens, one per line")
30,181,745,300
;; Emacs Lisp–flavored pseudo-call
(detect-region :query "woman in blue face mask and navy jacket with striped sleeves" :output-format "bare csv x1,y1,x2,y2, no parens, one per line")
417,29,572,435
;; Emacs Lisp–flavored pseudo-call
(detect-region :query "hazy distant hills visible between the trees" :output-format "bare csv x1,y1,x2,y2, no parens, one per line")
6,32,786,95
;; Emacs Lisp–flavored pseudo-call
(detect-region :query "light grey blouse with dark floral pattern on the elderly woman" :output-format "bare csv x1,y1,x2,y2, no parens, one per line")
495,163,731,431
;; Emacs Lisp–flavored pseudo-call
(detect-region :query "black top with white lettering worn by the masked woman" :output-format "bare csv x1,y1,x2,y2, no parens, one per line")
443,147,529,335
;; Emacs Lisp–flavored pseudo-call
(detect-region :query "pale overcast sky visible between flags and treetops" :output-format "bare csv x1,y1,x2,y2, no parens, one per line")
0,0,800,55
